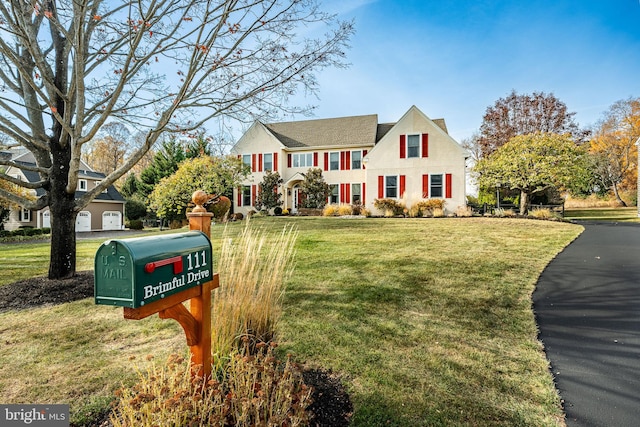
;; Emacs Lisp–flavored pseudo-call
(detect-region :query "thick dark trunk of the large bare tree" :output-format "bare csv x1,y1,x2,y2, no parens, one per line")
49,144,78,279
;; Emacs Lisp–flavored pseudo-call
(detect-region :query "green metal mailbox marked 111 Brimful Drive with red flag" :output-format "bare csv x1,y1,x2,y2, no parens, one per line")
94,231,213,308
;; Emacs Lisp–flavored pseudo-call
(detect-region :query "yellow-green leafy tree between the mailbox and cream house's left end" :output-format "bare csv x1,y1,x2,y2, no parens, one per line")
149,156,251,220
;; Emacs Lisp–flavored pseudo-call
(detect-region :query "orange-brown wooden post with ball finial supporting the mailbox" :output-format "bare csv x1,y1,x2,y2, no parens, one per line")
187,190,218,379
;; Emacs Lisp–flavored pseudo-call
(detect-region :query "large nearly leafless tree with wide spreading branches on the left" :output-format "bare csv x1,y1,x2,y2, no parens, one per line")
0,0,353,279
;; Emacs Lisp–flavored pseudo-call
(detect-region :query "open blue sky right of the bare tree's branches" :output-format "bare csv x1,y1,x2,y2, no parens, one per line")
306,0,640,141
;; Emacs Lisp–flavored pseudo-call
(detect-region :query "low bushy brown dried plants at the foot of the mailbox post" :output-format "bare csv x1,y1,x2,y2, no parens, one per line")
110,343,312,427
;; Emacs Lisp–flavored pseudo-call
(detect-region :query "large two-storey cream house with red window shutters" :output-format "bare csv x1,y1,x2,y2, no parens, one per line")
231,106,469,214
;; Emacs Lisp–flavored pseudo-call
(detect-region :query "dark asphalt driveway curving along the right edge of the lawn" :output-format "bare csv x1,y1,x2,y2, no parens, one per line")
533,222,640,427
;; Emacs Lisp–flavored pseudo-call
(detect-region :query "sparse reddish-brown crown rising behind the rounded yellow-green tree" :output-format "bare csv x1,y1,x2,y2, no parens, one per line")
476,90,587,157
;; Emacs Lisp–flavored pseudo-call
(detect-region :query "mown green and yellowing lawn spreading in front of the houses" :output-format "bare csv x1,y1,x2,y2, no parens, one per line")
0,218,582,426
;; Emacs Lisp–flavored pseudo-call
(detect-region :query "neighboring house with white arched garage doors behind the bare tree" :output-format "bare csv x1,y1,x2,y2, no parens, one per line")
4,152,125,231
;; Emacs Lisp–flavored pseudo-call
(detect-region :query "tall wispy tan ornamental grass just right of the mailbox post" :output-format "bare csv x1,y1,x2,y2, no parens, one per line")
211,221,298,356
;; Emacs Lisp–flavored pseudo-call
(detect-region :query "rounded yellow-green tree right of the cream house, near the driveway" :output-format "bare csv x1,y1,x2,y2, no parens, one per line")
474,133,588,215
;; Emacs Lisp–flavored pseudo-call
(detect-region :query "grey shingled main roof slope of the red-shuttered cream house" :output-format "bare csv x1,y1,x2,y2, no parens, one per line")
264,114,379,148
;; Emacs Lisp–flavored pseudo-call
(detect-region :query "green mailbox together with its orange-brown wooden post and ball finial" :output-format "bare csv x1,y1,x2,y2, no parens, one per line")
95,191,219,378
